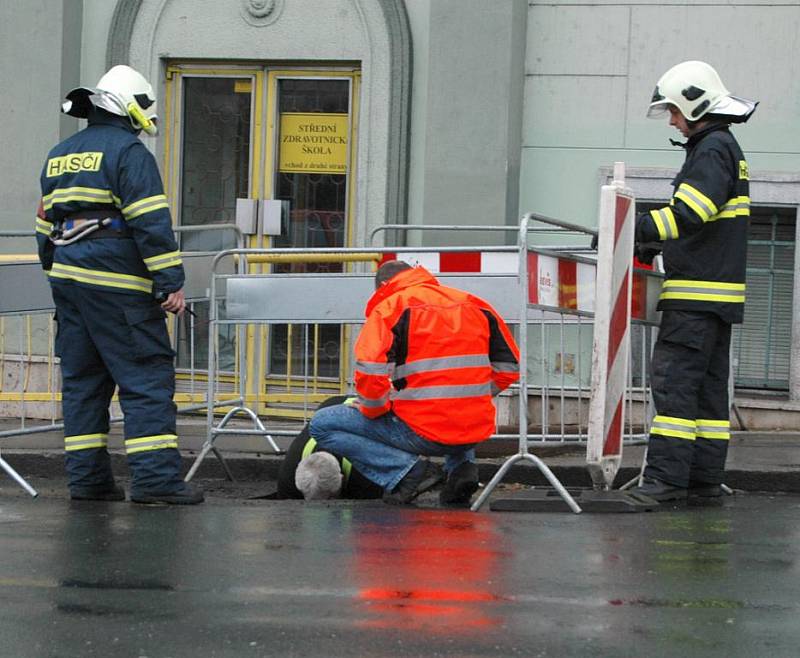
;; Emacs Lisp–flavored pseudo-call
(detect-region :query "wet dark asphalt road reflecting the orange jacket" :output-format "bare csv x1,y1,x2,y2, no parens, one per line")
0,491,800,658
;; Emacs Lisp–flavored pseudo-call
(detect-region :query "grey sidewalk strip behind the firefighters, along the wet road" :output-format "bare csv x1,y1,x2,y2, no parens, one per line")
0,420,800,497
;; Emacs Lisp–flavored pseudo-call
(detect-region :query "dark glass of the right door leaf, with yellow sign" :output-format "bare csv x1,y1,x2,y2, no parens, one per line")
269,73,352,380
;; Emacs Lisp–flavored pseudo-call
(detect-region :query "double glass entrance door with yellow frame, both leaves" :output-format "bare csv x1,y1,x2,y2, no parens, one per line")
165,63,360,404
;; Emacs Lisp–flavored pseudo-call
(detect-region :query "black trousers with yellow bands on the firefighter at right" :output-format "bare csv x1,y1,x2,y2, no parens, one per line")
644,310,731,487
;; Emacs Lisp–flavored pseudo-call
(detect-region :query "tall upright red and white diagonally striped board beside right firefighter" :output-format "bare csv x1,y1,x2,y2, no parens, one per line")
586,171,646,488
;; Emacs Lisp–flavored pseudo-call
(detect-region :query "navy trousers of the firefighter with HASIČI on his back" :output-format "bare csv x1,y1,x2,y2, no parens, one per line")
51,281,183,495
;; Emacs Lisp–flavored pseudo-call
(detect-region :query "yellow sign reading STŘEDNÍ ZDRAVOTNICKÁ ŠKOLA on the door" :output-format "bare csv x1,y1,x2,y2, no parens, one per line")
278,112,347,174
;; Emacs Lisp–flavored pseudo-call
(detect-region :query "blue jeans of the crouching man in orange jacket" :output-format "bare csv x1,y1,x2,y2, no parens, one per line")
309,404,475,491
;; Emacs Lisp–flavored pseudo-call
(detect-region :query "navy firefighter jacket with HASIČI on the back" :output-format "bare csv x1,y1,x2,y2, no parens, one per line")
36,110,184,295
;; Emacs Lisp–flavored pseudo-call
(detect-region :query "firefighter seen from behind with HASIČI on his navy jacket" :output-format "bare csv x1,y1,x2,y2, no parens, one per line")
36,66,203,504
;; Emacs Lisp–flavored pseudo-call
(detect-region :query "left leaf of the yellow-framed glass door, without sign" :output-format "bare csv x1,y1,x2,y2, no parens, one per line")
164,65,264,373
